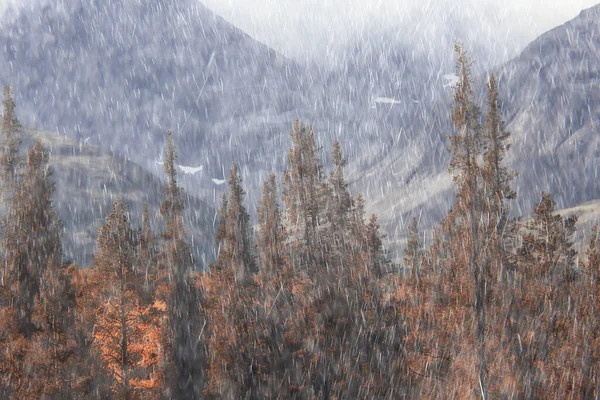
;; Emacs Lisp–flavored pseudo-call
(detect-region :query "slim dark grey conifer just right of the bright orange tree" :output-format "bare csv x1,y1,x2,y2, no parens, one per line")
161,132,205,399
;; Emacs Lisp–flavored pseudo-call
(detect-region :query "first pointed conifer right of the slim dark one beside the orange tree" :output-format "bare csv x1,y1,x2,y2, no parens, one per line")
208,164,258,398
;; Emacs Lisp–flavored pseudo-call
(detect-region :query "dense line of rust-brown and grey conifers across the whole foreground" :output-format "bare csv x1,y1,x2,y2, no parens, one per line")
0,46,600,399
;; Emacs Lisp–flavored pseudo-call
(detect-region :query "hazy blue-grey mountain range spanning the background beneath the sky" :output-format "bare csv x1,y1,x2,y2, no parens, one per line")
0,0,600,260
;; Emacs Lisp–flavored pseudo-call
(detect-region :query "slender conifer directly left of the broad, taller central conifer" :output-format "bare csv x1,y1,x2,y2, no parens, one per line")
250,174,302,398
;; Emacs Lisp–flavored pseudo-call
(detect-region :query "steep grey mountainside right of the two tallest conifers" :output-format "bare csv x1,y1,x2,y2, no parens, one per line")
499,5,600,213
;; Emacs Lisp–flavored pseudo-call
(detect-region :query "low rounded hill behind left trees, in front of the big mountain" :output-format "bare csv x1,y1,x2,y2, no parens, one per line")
22,130,215,268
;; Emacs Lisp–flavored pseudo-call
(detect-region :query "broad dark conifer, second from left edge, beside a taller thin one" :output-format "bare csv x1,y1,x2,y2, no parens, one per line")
3,140,74,396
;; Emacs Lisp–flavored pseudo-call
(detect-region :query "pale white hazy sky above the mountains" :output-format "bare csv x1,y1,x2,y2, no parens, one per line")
204,0,600,62
